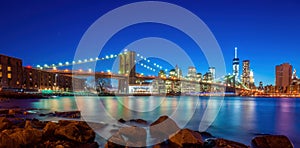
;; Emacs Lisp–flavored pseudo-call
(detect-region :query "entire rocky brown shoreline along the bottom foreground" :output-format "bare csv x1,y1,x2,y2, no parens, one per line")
0,109,293,148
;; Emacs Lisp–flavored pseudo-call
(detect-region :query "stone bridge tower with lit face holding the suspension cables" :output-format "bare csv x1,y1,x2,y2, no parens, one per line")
119,51,136,92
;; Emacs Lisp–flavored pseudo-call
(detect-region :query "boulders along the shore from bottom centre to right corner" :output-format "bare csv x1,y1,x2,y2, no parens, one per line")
105,116,293,148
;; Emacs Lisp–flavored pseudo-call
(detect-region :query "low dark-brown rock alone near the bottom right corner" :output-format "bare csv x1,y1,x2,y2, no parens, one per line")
251,135,294,148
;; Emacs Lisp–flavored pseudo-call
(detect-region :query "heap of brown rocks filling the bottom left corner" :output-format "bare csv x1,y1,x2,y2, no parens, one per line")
0,117,98,148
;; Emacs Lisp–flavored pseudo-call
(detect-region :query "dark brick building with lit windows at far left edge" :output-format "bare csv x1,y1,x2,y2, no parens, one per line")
0,54,22,91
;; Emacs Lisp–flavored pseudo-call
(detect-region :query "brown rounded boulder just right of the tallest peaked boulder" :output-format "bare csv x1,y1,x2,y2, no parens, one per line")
169,129,203,147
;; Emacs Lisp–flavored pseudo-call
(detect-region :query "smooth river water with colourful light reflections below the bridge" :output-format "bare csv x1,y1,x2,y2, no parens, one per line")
0,96,300,147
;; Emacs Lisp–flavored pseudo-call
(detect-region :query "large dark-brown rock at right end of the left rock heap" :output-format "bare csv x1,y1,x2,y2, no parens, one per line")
54,121,95,143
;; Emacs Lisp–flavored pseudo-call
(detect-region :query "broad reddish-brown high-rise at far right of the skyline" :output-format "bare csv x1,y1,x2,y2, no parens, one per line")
275,63,293,92
